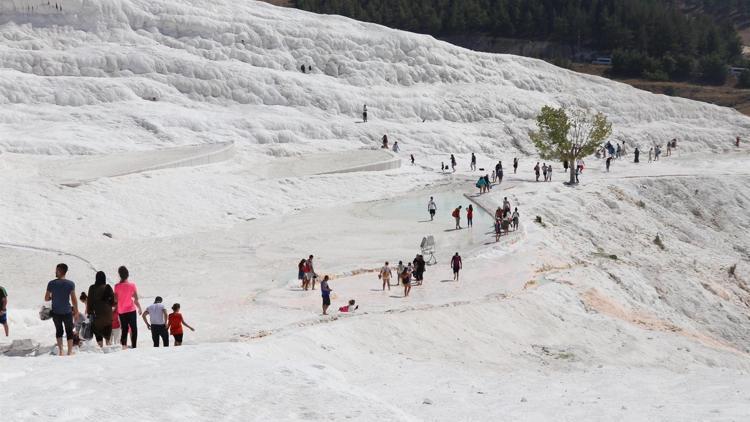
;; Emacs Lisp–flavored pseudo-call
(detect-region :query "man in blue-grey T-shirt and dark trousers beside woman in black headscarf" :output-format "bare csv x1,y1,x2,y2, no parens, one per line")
44,264,78,356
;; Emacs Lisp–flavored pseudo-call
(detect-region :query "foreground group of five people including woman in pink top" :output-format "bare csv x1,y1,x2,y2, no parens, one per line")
40,264,194,356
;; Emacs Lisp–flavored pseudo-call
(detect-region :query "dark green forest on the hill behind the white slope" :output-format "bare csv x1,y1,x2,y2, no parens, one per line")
296,0,747,84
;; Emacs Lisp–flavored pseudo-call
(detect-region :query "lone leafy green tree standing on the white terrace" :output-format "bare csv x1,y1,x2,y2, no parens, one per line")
529,106,612,185
